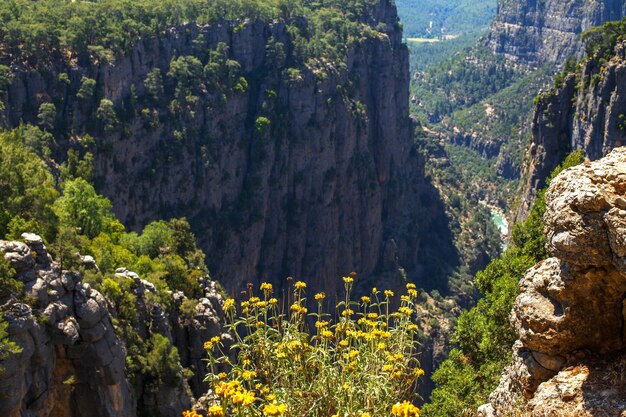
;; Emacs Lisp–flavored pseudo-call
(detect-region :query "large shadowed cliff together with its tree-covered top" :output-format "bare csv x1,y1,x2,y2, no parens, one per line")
0,0,466,300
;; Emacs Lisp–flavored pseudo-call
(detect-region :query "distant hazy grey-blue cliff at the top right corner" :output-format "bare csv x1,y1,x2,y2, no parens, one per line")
486,0,626,67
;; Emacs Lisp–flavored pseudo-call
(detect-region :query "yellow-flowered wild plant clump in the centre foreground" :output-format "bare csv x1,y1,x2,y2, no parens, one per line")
200,274,424,417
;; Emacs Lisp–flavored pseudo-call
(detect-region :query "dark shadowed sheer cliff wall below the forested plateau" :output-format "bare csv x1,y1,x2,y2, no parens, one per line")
0,0,457,300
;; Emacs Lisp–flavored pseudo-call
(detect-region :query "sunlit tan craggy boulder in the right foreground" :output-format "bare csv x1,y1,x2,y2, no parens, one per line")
481,148,626,416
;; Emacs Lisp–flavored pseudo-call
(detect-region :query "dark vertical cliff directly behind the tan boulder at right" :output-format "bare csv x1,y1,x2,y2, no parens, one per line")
518,44,626,217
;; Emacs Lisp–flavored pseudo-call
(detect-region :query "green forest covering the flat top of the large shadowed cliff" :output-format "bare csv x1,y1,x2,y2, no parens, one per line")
0,0,386,66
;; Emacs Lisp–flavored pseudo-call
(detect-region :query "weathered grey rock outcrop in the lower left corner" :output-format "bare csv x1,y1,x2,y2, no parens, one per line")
0,234,223,417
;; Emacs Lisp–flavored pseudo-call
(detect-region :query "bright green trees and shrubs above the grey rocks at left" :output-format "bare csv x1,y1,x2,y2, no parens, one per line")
0,126,208,385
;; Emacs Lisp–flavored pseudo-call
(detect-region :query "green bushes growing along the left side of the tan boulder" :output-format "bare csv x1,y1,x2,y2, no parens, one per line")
424,152,583,417
